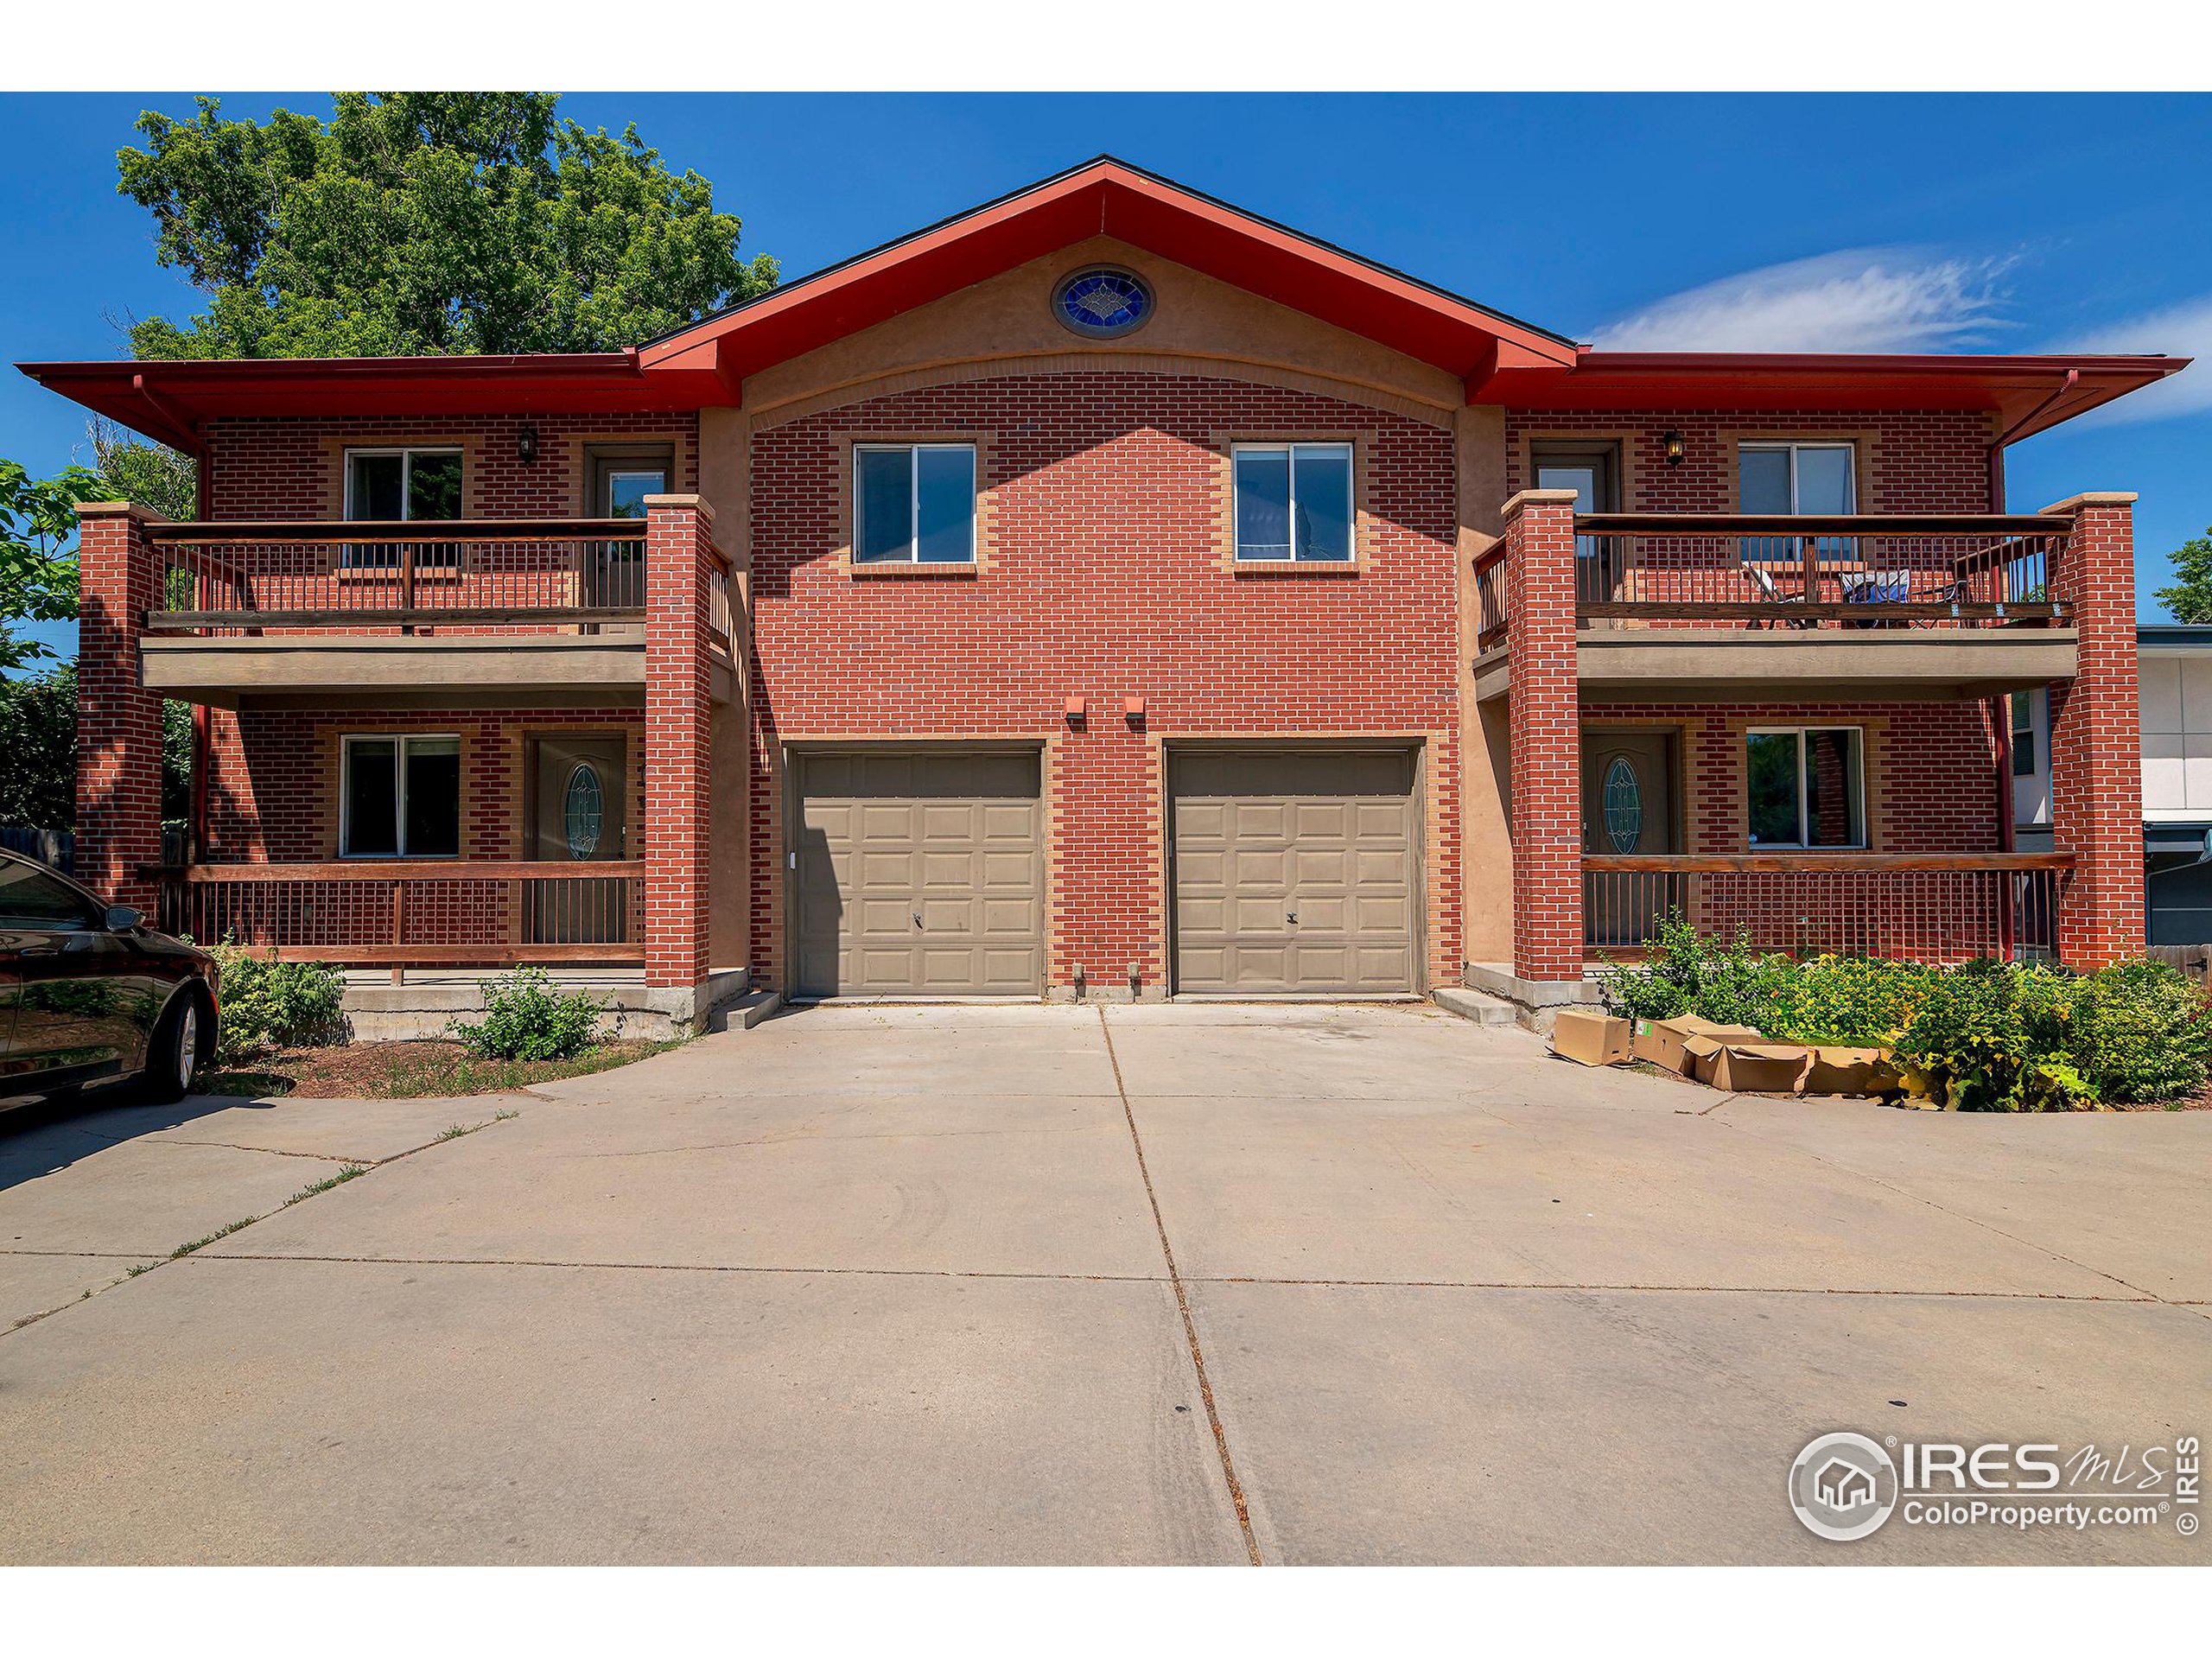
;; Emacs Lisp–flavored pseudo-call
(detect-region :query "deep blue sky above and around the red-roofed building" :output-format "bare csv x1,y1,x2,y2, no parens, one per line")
0,93,2212,664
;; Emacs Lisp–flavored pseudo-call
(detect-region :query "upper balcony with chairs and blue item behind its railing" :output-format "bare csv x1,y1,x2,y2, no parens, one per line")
1476,513,2077,699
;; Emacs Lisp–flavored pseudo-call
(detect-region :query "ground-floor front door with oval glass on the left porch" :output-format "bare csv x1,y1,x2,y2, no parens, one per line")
524,732,635,944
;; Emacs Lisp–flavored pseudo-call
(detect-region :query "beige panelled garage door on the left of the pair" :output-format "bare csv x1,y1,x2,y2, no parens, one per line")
791,752,1044,995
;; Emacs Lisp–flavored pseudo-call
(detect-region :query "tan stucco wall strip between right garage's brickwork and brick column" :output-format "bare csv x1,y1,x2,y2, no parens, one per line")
1451,404,1513,963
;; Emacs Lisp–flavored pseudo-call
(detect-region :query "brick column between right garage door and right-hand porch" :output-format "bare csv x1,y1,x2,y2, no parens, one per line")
1504,489,1581,980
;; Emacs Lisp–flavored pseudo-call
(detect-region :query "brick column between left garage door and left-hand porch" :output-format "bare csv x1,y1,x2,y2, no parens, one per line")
646,495,715,987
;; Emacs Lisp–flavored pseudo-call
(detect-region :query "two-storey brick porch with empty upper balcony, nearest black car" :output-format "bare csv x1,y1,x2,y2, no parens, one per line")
78,495,743,1035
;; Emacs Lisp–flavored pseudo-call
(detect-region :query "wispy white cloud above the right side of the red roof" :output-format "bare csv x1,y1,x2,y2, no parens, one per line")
1597,248,2011,352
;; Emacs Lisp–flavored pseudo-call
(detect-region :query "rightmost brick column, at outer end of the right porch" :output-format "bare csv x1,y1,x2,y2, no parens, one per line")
2044,493,2144,971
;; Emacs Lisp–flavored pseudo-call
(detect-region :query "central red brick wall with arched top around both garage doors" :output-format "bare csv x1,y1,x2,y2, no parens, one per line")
752,372,1460,991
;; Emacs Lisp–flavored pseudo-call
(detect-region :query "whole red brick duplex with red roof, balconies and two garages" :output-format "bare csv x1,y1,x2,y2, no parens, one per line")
24,159,2181,1022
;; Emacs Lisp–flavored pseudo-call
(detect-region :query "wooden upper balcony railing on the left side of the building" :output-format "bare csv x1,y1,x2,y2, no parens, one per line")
146,518,646,635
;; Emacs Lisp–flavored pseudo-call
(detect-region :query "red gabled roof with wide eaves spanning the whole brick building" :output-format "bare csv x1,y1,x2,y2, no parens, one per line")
17,157,2188,451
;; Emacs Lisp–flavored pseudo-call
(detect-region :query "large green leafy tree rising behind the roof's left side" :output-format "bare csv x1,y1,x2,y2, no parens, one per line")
118,93,777,359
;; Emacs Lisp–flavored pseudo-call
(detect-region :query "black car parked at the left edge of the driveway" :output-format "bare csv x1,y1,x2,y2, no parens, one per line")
0,852,219,1102
